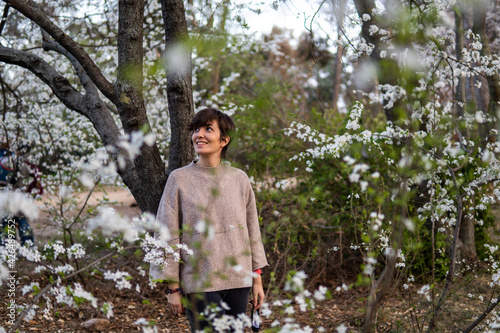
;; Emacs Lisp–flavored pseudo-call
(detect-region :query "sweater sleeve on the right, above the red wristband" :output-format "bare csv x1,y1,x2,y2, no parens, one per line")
246,177,269,271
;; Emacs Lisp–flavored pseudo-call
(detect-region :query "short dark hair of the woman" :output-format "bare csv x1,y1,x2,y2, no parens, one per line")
188,108,236,158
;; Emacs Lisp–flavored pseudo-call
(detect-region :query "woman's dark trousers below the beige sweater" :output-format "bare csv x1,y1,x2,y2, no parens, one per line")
186,287,250,332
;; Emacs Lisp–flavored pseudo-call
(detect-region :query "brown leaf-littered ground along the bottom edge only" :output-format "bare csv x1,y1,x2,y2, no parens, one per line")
0,257,496,333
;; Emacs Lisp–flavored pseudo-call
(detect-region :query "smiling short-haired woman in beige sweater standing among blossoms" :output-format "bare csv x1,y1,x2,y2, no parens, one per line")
151,109,268,331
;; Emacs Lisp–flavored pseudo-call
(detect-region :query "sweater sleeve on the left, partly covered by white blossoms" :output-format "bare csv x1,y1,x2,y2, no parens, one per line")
149,174,181,282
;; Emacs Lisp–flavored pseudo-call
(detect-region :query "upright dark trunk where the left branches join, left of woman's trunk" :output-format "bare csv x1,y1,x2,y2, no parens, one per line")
114,0,167,214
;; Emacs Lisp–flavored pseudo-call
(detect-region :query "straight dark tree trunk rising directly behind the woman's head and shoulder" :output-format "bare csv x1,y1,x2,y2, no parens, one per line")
161,0,194,174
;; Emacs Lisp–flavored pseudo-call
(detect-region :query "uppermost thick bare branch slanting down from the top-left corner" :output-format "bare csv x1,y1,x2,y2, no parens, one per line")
3,0,116,103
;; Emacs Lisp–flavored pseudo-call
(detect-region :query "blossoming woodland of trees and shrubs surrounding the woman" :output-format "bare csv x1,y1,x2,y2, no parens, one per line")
0,0,500,332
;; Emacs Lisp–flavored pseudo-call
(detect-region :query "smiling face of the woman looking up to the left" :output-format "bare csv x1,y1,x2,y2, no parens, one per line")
191,121,229,157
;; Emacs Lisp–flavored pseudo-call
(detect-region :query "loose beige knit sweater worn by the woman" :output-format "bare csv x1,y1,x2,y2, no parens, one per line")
150,162,268,293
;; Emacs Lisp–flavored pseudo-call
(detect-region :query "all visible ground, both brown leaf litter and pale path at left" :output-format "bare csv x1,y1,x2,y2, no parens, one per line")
0,188,498,333
